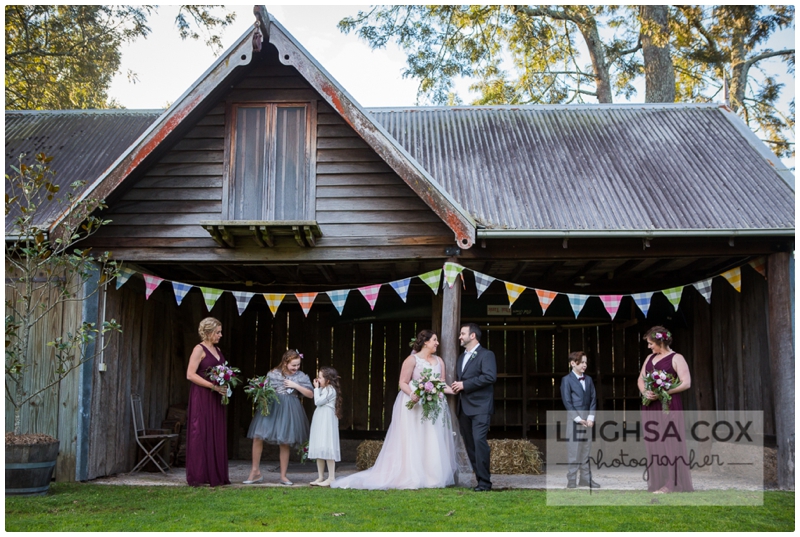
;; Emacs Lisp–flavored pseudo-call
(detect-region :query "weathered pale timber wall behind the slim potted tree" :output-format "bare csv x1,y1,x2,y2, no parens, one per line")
5,271,81,481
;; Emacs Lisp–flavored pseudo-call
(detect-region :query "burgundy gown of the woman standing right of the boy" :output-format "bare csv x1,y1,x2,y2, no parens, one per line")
642,353,694,492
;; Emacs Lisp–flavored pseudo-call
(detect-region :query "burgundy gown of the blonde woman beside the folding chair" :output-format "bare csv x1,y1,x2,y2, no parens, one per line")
186,344,231,487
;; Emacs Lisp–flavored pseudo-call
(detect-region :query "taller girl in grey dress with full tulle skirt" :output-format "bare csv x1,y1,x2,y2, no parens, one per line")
244,349,314,485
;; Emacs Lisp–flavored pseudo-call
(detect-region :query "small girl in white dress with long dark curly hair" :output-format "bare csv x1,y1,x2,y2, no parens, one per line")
308,367,342,487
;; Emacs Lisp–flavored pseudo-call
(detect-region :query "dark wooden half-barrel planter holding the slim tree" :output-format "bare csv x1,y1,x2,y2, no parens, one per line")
6,441,59,496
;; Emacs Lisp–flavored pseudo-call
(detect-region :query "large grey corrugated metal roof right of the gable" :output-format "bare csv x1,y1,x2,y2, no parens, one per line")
369,105,794,231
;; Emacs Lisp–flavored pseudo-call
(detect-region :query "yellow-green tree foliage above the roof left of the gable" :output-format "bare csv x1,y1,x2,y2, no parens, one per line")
5,5,235,110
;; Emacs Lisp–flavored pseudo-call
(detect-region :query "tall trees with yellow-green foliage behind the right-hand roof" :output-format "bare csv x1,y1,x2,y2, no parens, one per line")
339,5,794,156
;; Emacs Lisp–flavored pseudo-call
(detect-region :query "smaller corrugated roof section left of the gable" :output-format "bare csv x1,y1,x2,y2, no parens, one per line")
5,110,163,232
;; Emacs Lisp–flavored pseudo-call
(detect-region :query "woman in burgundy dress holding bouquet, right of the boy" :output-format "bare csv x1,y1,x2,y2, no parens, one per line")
639,326,694,494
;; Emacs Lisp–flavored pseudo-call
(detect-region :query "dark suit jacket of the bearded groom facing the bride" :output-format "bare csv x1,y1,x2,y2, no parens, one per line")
456,345,497,416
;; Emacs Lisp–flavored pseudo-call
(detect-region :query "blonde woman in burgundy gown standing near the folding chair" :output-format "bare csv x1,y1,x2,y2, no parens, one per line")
186,317,231,487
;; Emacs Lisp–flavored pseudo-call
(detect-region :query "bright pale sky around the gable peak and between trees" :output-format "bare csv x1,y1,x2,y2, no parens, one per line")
109,4,795,167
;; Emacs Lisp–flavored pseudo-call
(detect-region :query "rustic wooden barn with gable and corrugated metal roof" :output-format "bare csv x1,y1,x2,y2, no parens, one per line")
6,7,794,488
